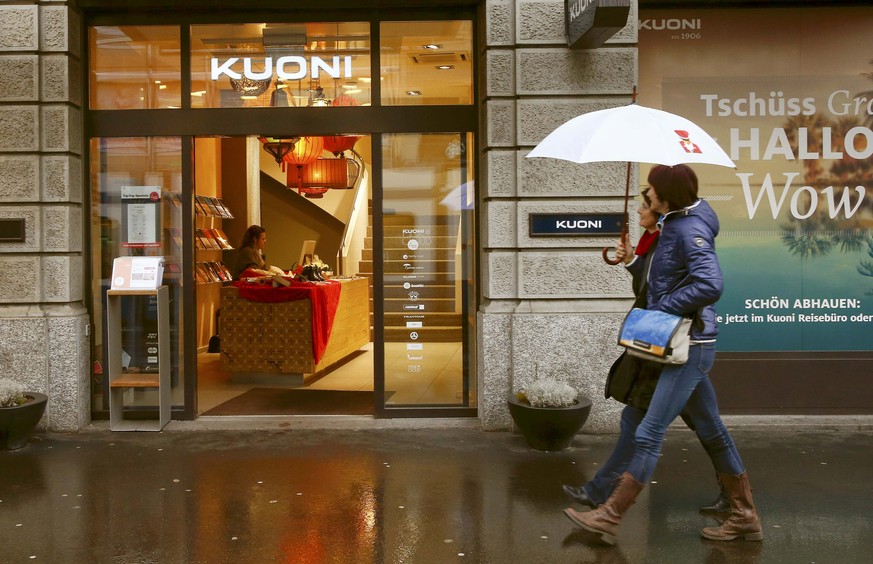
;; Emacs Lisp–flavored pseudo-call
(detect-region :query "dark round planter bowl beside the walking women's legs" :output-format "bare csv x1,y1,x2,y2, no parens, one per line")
507,396,591,451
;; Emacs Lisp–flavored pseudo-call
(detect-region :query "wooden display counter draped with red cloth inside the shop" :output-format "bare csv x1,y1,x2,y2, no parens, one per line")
220,278,370,376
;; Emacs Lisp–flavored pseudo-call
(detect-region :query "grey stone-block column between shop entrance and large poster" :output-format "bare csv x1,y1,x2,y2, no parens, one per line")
478,0,639,432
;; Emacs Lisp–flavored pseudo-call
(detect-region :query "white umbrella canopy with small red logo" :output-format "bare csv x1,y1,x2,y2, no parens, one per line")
527,104,736,168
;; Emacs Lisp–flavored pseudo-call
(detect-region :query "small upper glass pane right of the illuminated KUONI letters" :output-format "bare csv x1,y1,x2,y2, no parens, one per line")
379,20,473,106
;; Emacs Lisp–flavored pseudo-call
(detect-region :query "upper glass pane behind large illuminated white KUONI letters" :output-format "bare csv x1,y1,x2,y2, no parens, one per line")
191,22,372,108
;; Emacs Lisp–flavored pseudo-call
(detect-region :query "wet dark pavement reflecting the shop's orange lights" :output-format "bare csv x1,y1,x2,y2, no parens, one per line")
0,424,873,564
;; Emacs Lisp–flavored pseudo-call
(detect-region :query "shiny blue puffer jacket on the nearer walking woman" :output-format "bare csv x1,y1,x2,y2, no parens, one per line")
628,200,724,341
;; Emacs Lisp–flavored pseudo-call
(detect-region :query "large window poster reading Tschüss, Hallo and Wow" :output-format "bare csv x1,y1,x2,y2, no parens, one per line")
638,7,873,352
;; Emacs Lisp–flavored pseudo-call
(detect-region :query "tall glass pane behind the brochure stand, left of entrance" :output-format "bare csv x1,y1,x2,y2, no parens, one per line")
90,137,184,409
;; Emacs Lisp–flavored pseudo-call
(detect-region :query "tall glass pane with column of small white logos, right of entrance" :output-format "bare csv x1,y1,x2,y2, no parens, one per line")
382,133,476,407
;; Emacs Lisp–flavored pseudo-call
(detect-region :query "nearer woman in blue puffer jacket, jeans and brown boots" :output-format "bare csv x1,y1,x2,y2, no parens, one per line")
564,164,764,543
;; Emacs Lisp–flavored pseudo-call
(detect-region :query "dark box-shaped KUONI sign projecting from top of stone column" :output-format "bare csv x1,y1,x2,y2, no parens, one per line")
564,0,630,49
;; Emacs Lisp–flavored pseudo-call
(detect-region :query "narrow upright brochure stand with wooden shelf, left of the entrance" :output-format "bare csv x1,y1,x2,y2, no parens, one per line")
106,286,171,431
